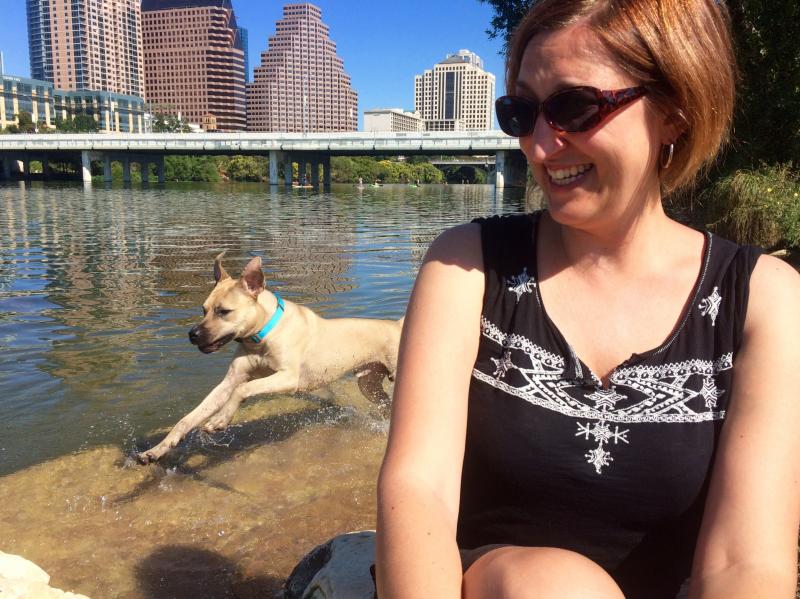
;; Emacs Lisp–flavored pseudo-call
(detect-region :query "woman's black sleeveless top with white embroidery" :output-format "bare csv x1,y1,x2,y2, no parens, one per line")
458,213,759,599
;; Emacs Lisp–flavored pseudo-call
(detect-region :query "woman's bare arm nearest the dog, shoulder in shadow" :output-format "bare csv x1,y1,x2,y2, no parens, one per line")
377,224,484,599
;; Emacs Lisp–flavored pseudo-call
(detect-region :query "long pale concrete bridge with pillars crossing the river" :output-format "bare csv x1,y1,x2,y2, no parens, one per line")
0,131,526,187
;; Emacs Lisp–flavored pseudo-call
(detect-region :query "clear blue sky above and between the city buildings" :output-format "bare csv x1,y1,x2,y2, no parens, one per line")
0,0,504,124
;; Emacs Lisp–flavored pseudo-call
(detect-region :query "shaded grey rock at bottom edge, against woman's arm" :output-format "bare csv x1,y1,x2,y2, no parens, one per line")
283,530,375,599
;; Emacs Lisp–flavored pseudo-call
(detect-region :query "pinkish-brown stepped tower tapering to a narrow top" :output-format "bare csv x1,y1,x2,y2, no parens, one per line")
247,3,358,132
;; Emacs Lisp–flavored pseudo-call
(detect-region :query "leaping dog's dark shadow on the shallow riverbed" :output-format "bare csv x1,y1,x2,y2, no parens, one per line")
114,402,353,505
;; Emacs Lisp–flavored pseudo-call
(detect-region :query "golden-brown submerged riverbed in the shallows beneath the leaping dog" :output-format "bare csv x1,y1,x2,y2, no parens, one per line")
0,380,386,599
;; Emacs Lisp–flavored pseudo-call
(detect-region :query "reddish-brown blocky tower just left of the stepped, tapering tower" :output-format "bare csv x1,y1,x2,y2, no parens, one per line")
142,0,247,131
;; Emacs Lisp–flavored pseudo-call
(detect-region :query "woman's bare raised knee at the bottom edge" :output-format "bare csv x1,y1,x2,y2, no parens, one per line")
463,547,624,599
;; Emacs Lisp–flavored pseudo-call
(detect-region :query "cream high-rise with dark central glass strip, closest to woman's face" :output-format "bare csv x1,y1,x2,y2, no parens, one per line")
414,50,495,131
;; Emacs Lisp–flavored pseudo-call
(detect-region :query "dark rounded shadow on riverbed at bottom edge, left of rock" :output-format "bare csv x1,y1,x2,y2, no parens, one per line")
134,545,283,599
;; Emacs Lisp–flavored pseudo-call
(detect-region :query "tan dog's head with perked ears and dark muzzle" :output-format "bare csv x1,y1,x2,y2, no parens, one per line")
189,252,264,354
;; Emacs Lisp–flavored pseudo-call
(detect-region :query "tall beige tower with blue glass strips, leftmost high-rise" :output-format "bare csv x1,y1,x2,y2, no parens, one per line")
26,0,144,97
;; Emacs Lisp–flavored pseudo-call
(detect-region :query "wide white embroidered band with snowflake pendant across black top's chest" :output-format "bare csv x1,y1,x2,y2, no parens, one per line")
472,316,733,474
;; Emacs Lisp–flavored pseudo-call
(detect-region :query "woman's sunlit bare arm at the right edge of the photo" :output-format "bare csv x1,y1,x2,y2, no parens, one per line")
689,256,800,599
